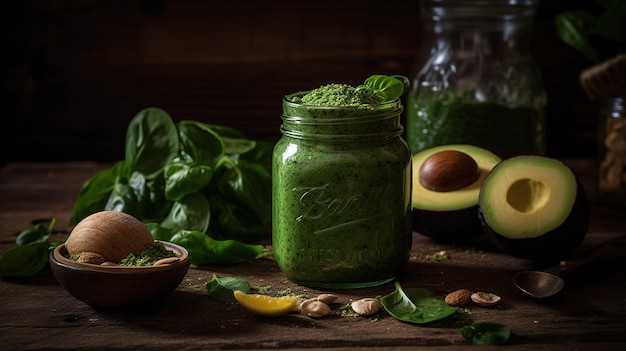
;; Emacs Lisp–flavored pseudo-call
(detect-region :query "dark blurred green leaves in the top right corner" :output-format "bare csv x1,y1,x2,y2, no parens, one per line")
555,0,626,64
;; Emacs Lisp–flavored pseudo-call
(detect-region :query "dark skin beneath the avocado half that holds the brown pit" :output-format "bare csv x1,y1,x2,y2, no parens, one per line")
413,206,484,244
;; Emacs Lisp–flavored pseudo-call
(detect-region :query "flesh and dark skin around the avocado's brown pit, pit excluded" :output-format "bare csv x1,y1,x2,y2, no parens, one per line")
412,144,500,243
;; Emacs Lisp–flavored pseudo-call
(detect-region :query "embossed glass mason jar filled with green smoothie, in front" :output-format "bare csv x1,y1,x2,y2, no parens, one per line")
272,93,412,289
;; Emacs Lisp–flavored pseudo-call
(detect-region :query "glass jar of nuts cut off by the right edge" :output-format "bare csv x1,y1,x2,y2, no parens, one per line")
598,98,626,208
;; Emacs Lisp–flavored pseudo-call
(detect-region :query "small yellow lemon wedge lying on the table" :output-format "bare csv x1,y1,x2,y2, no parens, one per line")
233,290,298,317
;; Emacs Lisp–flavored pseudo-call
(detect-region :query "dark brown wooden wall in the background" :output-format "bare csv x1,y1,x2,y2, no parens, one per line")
0,0,597,165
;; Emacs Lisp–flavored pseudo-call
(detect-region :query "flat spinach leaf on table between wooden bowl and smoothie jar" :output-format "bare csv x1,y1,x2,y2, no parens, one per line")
169,230,263,265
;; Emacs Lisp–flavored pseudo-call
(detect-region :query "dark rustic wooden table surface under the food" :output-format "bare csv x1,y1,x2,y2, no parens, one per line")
0,160,626,350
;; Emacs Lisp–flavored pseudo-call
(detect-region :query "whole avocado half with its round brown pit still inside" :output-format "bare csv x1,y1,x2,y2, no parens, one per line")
412,144,501,244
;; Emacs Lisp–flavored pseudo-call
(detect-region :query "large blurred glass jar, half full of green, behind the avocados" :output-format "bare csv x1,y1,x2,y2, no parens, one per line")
405,0,546,158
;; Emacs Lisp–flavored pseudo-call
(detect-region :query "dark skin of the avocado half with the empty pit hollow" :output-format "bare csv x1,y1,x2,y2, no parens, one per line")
478,179,590,265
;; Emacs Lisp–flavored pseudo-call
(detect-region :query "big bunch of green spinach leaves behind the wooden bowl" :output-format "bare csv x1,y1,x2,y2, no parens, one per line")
71,107,273,264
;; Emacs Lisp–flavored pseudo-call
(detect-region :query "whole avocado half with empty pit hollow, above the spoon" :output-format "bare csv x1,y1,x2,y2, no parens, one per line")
479,156,589,262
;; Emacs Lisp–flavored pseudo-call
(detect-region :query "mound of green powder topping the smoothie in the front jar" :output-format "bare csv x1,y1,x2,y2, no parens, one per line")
293,84,385,106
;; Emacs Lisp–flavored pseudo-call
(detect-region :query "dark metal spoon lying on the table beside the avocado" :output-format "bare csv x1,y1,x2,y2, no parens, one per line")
513,238,622,299
